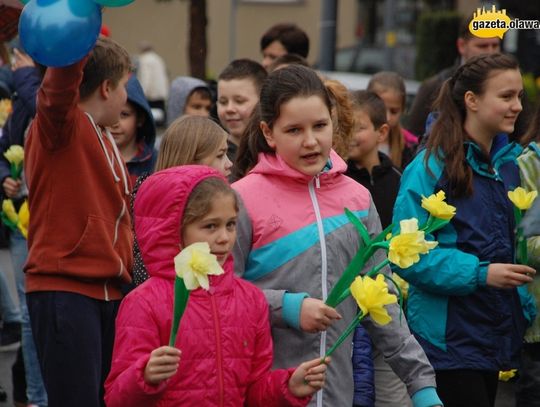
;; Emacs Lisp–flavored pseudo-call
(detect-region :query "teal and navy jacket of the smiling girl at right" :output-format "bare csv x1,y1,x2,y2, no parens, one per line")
394,135,536,371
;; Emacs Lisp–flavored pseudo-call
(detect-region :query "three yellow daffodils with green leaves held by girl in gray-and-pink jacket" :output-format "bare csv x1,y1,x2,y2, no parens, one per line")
325,191,456,357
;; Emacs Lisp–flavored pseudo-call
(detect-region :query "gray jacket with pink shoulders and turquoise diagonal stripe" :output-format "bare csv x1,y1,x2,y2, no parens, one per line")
233,151,441,406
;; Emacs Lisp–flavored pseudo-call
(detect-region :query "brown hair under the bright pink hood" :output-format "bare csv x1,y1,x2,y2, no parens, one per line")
181,177,238,230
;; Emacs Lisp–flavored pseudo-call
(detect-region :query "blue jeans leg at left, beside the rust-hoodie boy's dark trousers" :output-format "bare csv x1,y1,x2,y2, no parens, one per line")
10,231,47,407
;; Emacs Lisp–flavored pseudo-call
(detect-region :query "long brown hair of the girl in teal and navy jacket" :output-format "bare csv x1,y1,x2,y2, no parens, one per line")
425,54,519,197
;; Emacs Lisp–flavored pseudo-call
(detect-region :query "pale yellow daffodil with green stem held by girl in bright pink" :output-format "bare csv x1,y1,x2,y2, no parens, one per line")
169,242,223,346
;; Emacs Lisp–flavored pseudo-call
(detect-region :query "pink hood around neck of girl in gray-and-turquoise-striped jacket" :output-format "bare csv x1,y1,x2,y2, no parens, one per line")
249,150,347,182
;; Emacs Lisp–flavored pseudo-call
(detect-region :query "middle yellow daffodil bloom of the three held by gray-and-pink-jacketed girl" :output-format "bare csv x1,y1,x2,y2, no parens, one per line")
388,218,438,268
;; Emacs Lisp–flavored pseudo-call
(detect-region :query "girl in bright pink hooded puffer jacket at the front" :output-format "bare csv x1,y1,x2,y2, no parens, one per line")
105,166,326,407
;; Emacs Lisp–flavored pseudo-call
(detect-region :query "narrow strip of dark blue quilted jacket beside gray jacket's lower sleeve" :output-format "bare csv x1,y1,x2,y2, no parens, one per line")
352,325,375,407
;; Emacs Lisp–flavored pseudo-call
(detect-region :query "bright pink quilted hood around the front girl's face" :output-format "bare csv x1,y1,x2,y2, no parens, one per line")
133,165,232,279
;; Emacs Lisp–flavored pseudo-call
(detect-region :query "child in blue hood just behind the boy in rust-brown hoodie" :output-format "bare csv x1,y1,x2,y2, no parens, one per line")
109,75,157,185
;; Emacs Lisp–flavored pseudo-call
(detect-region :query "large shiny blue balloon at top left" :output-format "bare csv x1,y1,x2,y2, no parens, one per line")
19,0,101,67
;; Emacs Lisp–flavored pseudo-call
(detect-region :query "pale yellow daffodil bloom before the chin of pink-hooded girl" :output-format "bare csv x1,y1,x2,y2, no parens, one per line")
174,242,223,290
